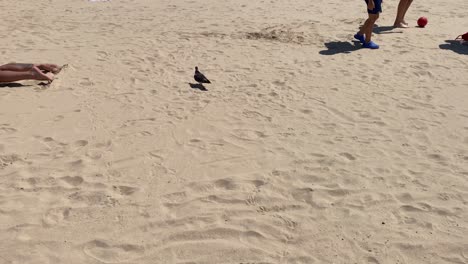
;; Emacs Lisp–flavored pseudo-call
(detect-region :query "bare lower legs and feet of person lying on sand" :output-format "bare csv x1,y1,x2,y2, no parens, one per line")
0,63,62,82
